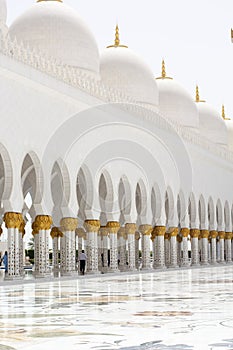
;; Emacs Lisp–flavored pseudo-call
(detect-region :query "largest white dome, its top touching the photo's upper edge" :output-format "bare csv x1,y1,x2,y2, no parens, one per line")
9,0,99,73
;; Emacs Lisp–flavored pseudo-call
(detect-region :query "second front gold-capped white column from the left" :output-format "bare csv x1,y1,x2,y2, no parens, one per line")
32,215,52,278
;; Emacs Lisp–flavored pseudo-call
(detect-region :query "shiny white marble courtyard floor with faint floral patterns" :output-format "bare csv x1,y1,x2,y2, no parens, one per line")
0,265,233,350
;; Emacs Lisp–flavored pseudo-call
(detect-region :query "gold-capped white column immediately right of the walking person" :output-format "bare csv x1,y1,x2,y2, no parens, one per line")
84,220,100,274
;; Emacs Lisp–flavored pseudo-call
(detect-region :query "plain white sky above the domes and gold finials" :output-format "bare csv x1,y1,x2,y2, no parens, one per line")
7,0,233,118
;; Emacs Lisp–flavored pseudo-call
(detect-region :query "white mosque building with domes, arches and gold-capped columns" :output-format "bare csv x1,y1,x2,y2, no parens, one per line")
0,0,233,279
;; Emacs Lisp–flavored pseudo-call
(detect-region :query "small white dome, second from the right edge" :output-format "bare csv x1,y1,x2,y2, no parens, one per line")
197,102,227,145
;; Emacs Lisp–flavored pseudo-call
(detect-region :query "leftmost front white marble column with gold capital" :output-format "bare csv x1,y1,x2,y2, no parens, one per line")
3,212,23,279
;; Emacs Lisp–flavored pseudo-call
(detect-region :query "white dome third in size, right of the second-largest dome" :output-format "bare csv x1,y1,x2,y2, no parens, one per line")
157,77,199,128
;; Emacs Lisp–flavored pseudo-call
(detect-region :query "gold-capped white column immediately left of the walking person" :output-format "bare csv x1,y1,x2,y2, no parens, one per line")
60,218,78,275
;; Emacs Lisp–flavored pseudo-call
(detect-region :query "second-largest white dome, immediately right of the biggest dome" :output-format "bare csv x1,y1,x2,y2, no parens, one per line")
100,32,158,106
